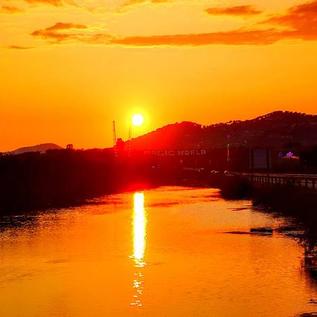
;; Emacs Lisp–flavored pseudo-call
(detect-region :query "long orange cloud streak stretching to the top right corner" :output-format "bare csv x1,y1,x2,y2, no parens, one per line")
32,0,317,47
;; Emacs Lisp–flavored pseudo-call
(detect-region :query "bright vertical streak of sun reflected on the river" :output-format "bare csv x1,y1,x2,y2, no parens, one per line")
131,193,147,307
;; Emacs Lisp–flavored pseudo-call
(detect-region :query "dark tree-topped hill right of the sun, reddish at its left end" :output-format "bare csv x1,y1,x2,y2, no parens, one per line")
130,111,317,150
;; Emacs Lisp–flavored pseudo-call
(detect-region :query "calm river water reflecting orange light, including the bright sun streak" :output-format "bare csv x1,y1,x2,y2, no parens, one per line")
0,187,317,317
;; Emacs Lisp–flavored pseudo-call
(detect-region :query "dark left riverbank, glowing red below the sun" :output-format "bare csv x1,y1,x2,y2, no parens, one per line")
0,149,208,215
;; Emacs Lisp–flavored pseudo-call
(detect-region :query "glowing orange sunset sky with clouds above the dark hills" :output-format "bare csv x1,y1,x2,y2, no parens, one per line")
0,0,317,151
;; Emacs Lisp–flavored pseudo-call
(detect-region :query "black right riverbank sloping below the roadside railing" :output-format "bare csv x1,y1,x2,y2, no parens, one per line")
220,176,317,254
